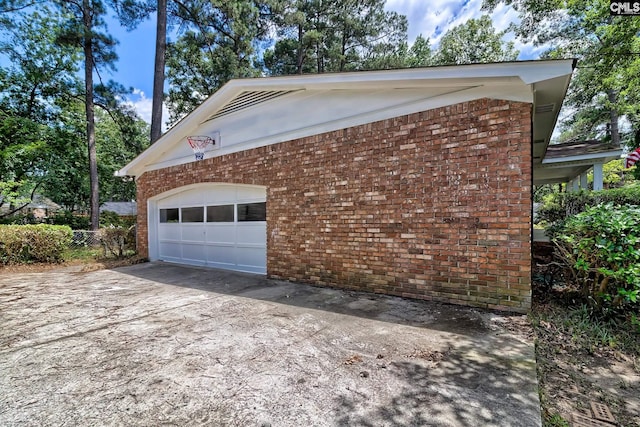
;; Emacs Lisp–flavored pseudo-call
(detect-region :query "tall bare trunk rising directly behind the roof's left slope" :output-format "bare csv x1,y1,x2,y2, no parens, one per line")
151,0,167,144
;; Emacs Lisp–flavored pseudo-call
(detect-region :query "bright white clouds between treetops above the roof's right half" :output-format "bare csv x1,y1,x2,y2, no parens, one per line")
385,0,548,59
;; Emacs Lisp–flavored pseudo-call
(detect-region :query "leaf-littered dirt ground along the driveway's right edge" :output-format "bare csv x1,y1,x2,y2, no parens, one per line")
531,244,640,427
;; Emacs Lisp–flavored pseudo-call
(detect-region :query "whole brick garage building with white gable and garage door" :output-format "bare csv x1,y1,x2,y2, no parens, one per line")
119,60,574,311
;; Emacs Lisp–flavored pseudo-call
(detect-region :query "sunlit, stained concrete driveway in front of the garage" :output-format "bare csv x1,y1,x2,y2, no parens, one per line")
0,263,540,427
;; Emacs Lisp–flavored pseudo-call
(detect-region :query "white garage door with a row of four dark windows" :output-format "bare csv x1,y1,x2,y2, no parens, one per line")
154,184,267,274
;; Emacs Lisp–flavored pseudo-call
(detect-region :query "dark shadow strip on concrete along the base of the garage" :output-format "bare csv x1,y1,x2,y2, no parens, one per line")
118,262,498,336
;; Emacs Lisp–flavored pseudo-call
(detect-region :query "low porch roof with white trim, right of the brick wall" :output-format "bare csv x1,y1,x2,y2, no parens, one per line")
534,140,622,185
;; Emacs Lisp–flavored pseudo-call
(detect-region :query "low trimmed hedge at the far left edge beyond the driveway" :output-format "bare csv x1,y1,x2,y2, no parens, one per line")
0,224,72,264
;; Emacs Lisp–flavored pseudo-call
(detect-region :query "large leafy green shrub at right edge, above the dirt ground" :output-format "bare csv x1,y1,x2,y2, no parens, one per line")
554,203,640,312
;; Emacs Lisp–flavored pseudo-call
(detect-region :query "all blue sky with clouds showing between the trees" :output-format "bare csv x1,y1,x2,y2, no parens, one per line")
109,0,542,125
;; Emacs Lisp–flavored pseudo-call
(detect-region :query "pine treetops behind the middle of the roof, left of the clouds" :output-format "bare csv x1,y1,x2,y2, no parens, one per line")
264,0,408,75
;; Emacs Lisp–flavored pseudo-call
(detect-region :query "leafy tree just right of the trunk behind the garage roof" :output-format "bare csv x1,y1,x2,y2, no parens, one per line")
166,0,268,123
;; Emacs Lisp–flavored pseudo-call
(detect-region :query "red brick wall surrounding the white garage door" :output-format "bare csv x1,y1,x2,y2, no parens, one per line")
138,99,532,311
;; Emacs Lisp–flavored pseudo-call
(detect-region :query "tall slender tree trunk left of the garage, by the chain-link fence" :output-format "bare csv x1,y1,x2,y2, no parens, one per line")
82,0,100,230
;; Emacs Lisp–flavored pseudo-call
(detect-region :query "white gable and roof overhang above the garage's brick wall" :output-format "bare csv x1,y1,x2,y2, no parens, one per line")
116,60,575,176
